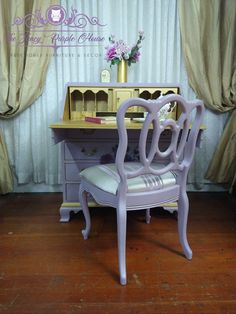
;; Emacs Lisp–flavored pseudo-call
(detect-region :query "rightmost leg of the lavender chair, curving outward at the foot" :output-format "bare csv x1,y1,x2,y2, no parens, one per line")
178,191,192,259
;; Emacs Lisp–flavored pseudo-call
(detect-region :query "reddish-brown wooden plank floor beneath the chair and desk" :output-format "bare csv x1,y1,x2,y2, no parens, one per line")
0,193,236,314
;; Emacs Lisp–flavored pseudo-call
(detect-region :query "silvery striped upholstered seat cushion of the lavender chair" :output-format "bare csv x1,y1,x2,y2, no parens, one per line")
80,162,176,195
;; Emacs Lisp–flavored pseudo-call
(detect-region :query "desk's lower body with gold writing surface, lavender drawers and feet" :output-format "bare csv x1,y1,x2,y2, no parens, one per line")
50,121,192,222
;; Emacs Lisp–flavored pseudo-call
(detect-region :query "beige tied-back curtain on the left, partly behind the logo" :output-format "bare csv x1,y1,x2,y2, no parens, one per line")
0,0,53,193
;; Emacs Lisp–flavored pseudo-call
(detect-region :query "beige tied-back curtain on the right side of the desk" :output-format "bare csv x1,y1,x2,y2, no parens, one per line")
179,0,236,192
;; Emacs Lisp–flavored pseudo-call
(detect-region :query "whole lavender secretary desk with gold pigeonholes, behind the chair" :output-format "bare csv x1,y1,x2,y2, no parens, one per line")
50,83,188,222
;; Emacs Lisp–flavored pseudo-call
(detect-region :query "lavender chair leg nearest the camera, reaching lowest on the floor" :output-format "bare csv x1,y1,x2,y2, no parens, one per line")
116,201,127,285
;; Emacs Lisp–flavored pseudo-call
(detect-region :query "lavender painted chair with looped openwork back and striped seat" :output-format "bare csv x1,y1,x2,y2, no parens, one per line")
79,95,204,285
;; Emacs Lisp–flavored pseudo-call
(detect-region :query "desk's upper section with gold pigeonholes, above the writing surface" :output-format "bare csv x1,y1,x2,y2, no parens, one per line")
63,83,180,120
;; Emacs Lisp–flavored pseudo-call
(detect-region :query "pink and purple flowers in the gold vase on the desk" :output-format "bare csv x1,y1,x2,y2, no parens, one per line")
105,31,144,66
